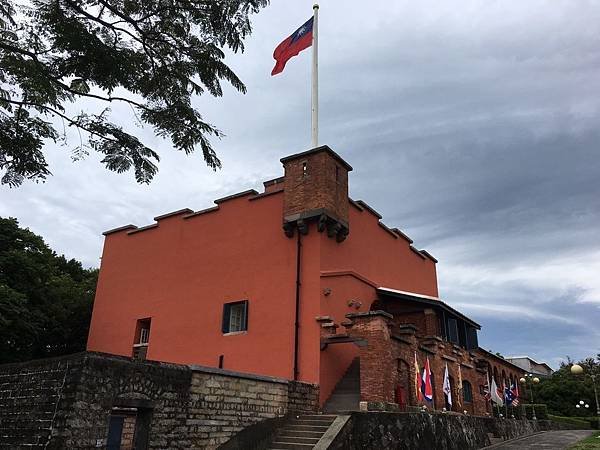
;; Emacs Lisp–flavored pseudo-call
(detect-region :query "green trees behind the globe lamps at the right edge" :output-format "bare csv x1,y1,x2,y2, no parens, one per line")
534,354,600,416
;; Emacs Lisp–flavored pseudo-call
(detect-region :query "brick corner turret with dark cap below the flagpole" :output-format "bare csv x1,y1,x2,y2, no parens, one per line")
281,145,352,242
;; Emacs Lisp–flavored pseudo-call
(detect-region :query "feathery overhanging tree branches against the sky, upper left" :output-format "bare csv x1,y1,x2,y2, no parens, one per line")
0,0,268,186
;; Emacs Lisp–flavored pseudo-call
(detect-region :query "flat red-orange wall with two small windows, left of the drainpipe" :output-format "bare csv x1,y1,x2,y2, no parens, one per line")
88,194,316,381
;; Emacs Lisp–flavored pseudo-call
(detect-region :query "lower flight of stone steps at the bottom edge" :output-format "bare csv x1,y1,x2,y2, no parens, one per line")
268,414,337,450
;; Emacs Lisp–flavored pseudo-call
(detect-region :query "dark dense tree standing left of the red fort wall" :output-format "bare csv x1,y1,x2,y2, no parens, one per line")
0,217,98,363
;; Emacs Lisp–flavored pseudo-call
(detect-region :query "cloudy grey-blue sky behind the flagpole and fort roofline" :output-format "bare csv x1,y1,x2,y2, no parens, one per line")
0,0,600,367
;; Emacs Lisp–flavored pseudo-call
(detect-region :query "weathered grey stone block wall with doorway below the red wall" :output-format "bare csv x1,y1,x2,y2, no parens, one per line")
0,353,318,449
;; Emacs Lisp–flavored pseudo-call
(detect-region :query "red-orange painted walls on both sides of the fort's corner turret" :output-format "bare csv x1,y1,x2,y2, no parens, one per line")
88,181,437,403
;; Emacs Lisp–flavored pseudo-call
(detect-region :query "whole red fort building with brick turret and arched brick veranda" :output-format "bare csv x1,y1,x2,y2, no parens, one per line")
87,146,524,415
